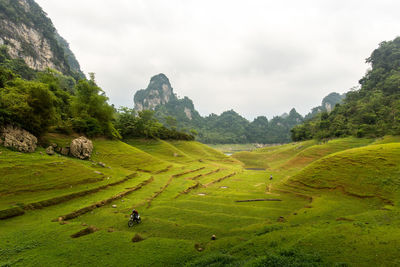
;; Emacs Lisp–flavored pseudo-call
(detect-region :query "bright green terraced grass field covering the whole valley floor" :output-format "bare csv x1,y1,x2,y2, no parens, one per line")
0,136,400,266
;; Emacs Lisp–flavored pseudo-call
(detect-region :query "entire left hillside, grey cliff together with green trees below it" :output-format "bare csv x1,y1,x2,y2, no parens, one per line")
0,0,194,141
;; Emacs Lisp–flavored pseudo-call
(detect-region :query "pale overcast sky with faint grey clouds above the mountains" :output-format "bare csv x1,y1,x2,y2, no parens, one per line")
36,0,400,119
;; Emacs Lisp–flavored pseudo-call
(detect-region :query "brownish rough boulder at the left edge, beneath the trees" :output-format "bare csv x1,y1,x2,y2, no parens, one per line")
0,125,37,152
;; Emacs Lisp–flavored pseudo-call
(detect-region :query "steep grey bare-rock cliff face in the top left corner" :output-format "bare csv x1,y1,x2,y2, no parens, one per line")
0,0,83,75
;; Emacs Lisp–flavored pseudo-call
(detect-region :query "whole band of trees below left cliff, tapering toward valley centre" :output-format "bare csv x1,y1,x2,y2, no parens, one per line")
0,46,194,140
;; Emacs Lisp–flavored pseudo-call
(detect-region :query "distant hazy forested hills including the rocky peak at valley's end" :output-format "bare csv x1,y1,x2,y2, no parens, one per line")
134,74,343,144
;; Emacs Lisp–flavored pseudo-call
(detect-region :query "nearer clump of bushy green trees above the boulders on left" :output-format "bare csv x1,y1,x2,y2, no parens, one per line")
0,62,120,137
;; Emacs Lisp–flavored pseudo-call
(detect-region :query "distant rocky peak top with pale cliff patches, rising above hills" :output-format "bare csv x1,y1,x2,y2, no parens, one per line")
134,73,177,111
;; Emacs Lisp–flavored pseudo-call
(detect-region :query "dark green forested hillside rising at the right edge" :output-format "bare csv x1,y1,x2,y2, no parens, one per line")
292,37,400,141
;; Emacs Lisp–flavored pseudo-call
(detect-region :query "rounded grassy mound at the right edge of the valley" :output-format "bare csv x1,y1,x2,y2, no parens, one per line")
288,143,400,201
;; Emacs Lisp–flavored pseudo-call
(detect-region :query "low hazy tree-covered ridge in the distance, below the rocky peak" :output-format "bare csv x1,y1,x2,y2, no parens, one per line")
156,104,303,144
